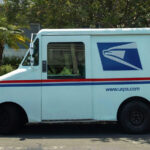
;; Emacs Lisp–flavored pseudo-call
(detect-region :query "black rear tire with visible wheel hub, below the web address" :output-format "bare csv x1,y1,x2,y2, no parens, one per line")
118,101,150,133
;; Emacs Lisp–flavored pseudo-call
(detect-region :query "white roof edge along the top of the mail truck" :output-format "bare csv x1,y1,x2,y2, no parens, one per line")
38,28,150,35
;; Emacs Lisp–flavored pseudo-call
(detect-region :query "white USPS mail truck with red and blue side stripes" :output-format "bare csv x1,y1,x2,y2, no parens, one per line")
0,28,150,133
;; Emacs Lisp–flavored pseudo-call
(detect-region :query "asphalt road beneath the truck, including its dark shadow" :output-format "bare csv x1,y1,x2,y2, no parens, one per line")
0,124,150,150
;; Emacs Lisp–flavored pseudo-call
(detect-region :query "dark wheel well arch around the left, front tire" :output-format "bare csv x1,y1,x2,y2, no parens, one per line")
0,102,28,124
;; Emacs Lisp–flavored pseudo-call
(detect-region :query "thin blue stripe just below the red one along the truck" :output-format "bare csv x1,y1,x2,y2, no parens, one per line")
0,81,150,87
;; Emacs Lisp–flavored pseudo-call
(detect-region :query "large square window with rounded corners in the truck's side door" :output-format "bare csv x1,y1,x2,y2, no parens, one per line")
47,42,85,79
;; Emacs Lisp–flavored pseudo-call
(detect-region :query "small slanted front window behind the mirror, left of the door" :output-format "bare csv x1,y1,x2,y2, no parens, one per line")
22,39,39,66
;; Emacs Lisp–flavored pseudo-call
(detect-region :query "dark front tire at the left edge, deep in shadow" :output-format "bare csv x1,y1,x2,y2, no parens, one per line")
0,105,21,134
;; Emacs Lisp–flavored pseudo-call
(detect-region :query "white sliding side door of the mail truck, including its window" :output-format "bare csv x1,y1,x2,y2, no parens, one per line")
42,36,93,121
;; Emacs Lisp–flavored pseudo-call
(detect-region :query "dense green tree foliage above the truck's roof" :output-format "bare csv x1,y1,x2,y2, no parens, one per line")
2,0,150,28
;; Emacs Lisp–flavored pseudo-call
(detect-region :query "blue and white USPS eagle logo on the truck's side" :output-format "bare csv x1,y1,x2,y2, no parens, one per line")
97,42,142,71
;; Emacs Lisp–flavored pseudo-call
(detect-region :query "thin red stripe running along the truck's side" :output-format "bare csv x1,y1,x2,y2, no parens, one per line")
0,77,150,83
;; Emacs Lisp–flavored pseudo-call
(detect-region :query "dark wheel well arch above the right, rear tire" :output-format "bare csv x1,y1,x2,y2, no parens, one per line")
117,96,150,120
